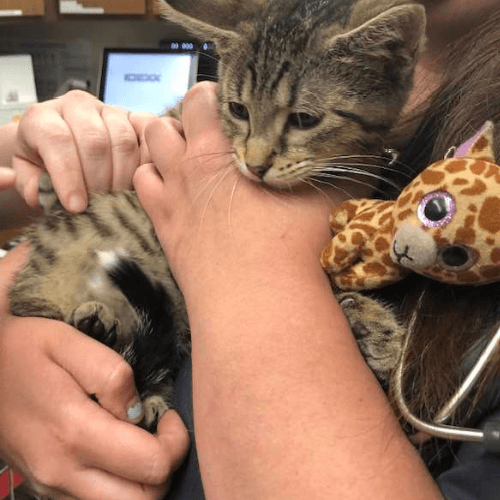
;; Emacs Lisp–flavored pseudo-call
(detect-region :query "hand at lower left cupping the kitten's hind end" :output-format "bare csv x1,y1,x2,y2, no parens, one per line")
0,245,189,500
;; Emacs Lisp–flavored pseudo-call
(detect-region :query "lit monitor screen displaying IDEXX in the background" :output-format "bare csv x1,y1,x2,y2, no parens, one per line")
99,49,198,114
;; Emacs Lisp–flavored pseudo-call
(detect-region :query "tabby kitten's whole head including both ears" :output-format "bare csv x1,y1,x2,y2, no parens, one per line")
161,0,425,187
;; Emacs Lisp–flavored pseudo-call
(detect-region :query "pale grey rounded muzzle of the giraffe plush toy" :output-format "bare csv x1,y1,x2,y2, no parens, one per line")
391,224,437,272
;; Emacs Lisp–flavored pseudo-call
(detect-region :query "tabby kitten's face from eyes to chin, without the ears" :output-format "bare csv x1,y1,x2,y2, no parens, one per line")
219,54,394,187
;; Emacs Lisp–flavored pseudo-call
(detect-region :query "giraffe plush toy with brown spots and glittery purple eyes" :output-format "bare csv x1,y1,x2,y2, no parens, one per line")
321,122,500,290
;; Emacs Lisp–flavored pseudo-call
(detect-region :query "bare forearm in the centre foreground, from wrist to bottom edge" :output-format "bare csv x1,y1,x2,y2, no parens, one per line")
188,256,441,500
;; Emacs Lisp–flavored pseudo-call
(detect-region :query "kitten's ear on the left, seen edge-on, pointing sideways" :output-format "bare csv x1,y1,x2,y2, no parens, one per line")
158,0,242,53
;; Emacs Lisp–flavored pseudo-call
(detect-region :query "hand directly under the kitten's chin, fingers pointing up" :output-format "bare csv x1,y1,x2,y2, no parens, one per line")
134,83,350,292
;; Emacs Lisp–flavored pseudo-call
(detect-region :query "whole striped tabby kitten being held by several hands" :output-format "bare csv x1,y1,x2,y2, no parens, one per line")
10,0,425,428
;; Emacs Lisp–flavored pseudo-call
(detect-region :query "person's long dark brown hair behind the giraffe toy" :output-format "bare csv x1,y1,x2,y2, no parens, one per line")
377,9,500,434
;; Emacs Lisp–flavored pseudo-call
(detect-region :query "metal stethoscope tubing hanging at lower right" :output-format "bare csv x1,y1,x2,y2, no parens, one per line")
394,296,500,453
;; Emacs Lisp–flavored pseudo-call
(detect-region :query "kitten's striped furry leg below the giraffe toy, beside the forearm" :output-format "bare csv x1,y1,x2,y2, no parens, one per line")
336,292,406,385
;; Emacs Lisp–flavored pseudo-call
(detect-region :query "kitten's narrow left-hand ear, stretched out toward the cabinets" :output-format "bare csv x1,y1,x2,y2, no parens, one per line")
158,0,241,52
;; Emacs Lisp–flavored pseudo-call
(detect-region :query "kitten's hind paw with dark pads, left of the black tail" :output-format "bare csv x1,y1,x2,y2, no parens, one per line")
69,302,119,347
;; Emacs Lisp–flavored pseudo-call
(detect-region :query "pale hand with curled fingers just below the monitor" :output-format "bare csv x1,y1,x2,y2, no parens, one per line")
12,90,155,212
